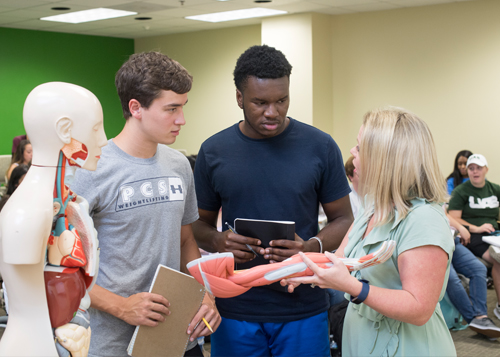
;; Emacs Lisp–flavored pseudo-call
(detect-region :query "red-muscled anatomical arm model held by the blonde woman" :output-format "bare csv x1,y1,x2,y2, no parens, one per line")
187,241,396,298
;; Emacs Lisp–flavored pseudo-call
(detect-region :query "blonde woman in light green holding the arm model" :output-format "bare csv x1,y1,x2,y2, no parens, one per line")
282,108,456,356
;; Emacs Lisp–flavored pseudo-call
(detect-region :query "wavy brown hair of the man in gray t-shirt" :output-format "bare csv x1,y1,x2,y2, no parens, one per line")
115,52,193,119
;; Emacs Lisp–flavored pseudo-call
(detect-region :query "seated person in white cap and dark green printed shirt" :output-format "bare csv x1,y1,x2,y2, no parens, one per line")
448,154,500,319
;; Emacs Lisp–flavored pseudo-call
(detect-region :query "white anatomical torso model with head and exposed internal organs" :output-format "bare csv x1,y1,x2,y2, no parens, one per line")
0,82,107,357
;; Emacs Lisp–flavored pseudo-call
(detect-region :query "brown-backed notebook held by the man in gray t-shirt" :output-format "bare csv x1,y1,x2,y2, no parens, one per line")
127,264,205,357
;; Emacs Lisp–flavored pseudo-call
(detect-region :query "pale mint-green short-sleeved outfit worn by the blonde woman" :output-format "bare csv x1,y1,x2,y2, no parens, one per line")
342,199,456,357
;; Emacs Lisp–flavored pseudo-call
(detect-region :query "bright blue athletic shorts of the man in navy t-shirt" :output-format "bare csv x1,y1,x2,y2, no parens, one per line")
210,311,330,357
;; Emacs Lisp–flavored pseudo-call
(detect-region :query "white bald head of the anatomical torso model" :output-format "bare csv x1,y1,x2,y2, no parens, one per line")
23,82,107,170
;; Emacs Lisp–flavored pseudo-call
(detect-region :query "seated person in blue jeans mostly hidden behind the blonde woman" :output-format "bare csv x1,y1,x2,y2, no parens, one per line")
446,215,500,338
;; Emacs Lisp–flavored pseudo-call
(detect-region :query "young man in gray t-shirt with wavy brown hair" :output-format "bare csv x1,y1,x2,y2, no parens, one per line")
71,52,220,356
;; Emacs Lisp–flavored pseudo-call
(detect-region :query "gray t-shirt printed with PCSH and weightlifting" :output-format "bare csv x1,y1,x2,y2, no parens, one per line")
71,140,198,357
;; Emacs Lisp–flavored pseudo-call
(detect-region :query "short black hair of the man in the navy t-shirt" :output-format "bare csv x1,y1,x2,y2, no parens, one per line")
233,45,292,91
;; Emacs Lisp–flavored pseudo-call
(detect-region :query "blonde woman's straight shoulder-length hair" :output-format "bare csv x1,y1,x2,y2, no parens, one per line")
359,107,446,225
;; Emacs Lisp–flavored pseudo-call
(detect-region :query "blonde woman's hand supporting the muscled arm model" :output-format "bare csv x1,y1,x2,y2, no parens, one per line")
280,252,360,296
